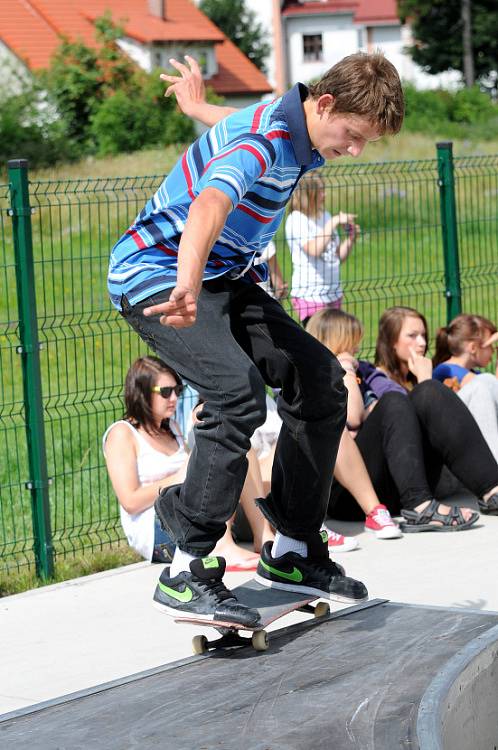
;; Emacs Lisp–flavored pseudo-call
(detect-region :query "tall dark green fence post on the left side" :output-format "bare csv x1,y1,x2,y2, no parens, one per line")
7,159,54,578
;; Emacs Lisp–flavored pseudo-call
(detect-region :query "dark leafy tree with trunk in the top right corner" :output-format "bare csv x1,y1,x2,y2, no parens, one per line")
398,0,498,90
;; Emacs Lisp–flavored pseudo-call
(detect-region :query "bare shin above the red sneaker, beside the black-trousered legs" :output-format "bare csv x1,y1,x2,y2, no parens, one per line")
334,429,380,516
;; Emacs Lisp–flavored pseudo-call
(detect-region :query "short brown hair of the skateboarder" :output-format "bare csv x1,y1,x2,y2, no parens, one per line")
309,50,405,135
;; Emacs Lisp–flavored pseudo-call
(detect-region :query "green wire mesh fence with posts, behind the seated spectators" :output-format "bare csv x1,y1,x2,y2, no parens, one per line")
0,144,498,577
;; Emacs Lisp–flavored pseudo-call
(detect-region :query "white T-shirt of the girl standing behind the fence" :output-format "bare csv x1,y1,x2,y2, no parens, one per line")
285,211,342,302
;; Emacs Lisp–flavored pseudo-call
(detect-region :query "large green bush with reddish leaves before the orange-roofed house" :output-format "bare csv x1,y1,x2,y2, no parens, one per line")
42,15,195,154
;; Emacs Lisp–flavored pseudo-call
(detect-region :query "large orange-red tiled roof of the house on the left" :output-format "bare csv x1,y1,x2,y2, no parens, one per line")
0,0,271,94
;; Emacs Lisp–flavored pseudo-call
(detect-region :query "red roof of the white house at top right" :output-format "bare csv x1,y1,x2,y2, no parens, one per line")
282,0,399,24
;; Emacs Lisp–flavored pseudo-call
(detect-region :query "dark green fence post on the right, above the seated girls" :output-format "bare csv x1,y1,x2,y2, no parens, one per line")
436,141,462,323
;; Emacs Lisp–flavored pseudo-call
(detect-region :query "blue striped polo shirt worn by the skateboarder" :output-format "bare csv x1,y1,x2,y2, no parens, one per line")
108,84,324,310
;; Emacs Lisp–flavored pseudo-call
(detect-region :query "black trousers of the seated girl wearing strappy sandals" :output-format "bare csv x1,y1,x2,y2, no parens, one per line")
329,380,498,520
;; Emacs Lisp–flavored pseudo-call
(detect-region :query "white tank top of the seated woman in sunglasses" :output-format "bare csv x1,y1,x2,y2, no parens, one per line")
102,419,188,561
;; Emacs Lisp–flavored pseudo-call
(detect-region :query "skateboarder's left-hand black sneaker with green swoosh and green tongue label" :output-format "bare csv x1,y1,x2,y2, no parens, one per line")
154,557,259,628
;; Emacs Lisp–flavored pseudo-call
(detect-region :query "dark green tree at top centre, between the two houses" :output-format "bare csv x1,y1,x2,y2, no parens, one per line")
199,0,270,71
